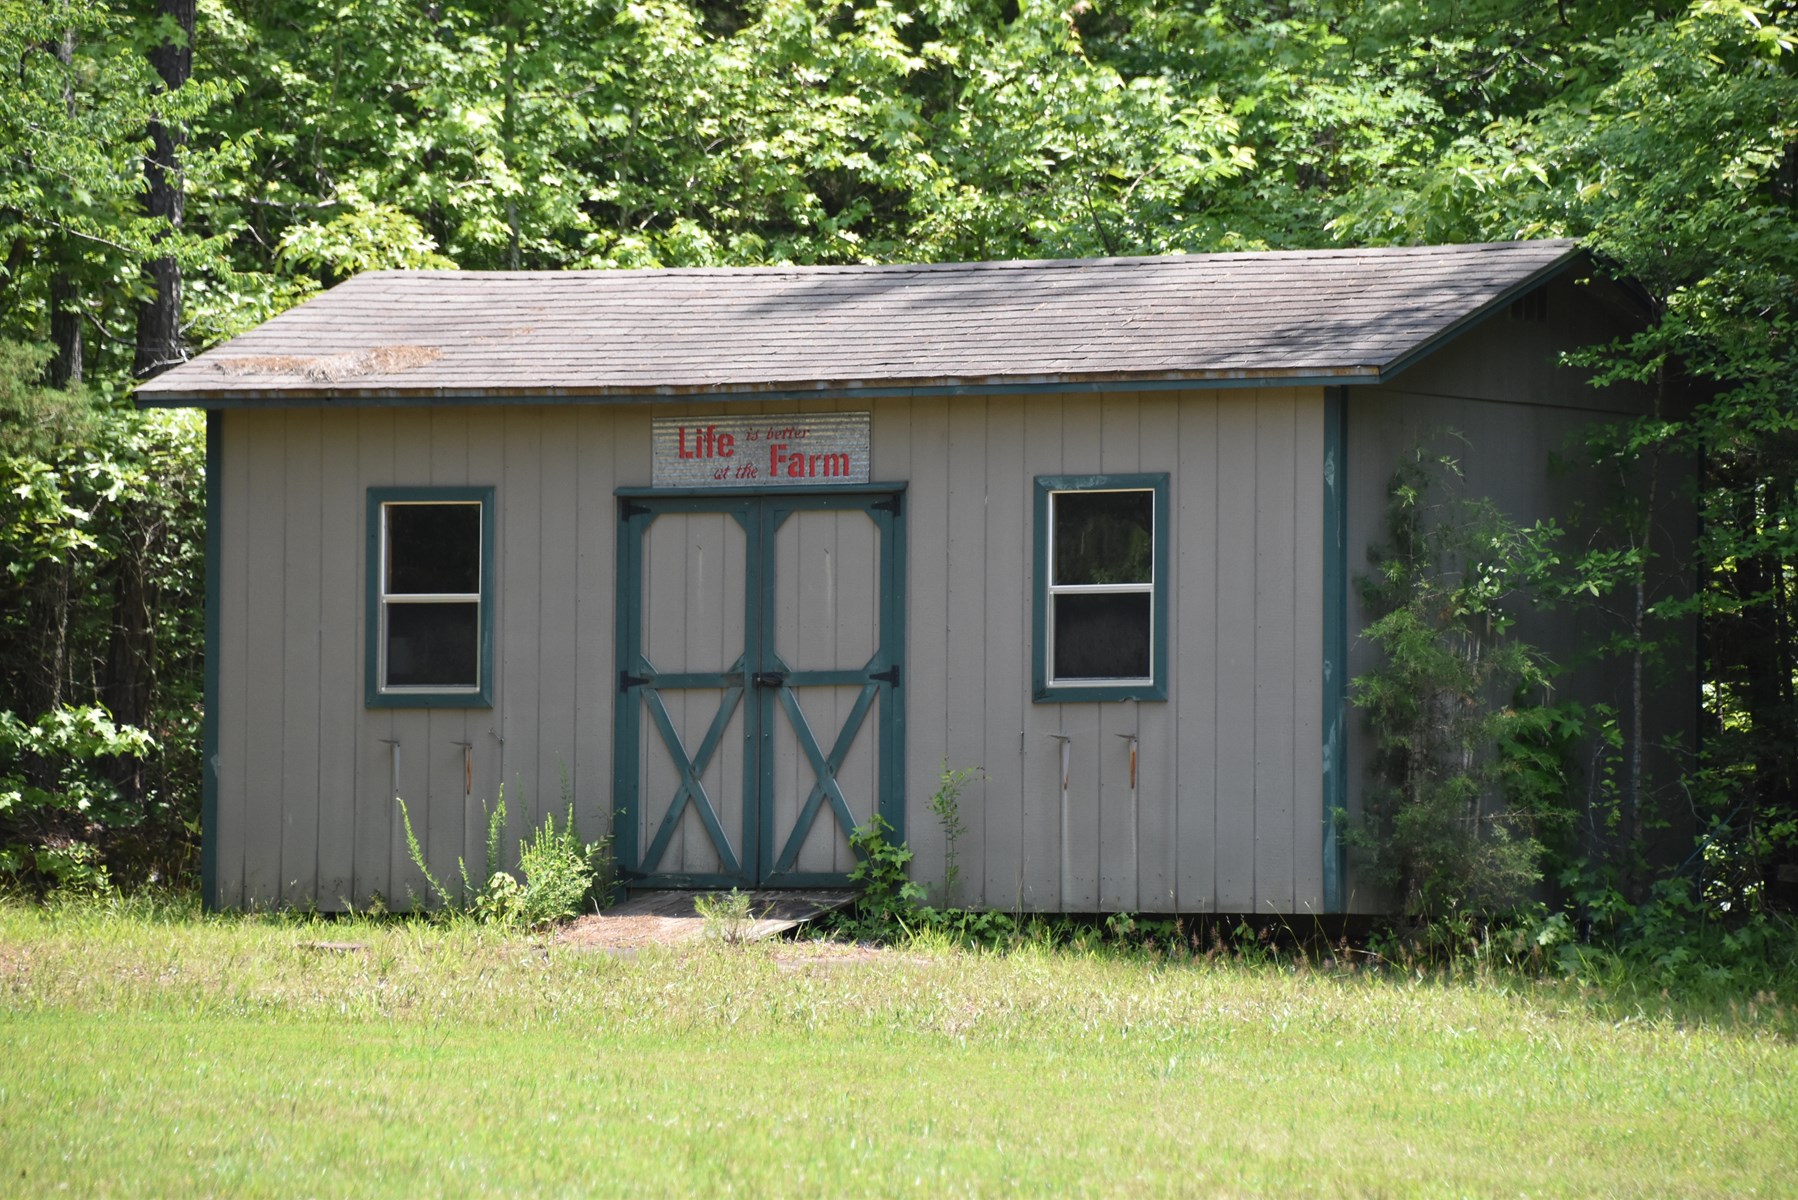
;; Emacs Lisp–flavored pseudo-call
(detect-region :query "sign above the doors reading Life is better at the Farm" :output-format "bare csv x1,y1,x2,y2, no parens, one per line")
651,412,868,488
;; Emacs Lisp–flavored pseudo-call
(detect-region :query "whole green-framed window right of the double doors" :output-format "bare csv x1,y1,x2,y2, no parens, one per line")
1034,475,1167,702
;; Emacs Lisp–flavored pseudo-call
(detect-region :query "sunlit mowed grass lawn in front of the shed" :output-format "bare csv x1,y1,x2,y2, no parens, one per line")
0,905,1798,1196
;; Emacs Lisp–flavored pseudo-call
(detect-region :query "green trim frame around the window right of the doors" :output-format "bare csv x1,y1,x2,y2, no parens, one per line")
1030,471,1172,703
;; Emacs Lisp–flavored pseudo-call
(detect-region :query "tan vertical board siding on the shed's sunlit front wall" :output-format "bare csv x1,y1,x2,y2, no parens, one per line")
210,389,1323,912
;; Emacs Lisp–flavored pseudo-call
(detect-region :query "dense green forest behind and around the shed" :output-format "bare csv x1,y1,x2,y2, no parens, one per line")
0,0,1798,961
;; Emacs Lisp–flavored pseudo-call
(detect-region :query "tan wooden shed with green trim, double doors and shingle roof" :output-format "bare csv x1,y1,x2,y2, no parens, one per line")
137,241,1668,914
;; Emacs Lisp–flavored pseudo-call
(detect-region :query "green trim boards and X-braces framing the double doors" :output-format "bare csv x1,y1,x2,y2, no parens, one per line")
613,484,904,889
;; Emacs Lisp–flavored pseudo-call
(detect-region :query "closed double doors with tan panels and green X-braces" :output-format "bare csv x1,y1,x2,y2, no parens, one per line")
613,488,904,887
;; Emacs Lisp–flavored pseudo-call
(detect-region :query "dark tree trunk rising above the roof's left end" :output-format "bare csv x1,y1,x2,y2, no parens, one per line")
133,0,194,380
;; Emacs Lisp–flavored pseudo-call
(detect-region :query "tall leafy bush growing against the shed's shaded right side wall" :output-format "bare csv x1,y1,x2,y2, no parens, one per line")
1349,446,1591,919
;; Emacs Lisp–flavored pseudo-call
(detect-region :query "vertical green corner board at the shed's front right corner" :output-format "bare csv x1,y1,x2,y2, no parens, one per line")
1322,389,1349,912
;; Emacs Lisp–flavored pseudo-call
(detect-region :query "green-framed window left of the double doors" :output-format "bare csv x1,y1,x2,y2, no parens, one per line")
367,488,493,709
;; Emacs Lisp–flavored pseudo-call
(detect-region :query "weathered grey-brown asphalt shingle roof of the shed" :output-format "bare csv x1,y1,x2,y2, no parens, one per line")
137,241,1579,405
